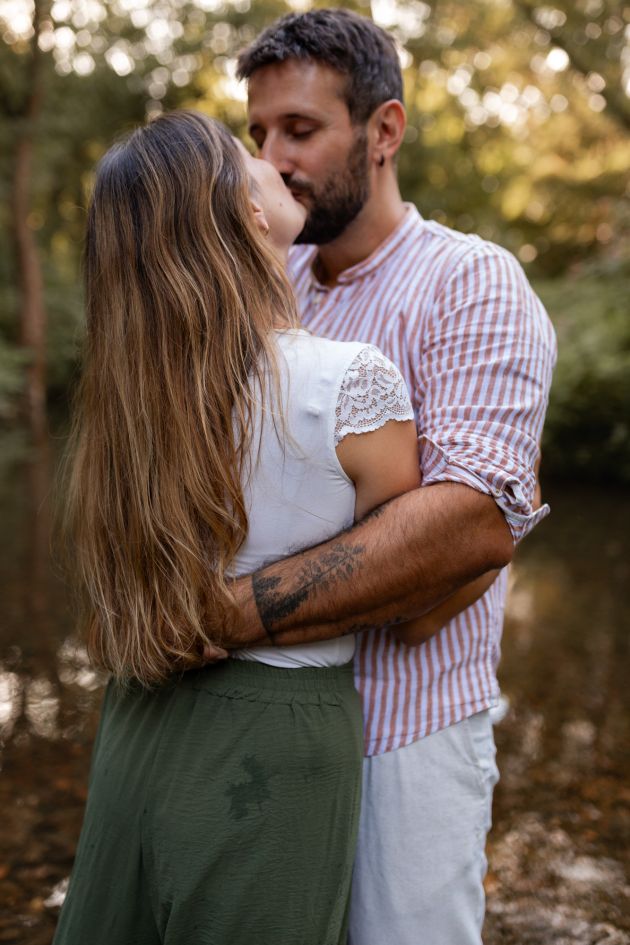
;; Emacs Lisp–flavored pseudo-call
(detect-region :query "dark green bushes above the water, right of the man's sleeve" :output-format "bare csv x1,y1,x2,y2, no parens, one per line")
535,267,630,482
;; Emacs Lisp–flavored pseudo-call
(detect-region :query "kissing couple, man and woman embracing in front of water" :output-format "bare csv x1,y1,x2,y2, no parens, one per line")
55,10,555,945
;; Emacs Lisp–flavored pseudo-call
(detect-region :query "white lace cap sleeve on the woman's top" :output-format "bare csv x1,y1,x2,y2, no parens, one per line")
335,345,413,446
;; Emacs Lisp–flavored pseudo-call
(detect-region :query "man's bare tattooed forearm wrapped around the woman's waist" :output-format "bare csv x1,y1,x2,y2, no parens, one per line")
221,483,513,647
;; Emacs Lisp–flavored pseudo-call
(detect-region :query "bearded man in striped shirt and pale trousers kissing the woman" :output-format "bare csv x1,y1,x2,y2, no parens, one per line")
210,10,555,945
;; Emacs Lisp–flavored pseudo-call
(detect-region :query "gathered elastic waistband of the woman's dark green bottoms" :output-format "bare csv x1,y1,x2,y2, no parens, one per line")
177,659,354,692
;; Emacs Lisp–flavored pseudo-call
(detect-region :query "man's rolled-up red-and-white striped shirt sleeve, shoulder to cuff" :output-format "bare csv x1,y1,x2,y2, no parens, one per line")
416,243,556,542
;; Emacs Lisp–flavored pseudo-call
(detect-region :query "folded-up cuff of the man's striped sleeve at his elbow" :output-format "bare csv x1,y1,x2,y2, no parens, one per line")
419,436,550,544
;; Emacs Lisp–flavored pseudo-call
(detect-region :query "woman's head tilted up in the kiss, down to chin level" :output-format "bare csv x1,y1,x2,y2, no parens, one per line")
87,112,304,306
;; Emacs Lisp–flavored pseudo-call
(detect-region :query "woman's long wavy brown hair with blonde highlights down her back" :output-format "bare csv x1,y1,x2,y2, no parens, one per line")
65,112,297,685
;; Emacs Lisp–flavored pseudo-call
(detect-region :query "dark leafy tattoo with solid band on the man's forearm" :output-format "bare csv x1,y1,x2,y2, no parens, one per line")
252,543,365,643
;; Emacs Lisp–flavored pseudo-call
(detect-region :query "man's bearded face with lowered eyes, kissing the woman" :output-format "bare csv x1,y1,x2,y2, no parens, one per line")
249,59,376,245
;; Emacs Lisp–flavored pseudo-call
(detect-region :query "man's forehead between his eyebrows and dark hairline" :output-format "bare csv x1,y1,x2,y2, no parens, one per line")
248,59,347,118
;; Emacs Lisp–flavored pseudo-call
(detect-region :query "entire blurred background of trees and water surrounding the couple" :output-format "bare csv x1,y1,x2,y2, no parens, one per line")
0,0,630,945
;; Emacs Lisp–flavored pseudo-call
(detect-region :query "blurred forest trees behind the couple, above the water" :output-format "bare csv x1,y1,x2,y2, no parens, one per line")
0,0,630,472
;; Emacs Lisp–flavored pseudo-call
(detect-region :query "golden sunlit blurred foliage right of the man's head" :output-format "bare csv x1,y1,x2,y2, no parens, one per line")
398,0,630,275
